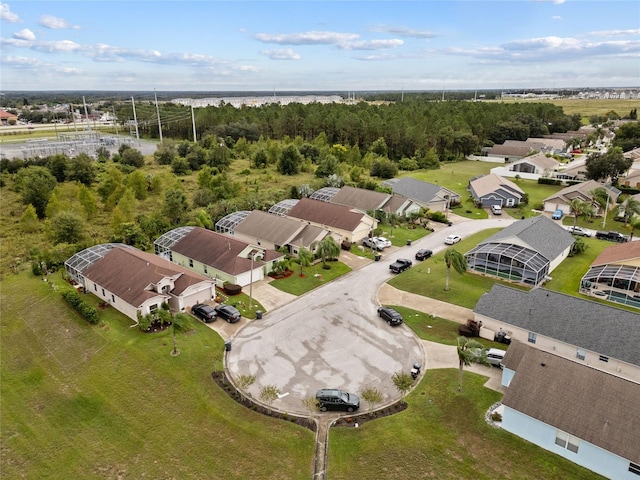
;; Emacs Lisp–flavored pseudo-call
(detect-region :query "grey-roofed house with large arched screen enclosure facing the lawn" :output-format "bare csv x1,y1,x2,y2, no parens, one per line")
465,215,575,286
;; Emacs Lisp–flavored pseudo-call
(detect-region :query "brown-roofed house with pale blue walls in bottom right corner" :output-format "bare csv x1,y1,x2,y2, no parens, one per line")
501,342,640,479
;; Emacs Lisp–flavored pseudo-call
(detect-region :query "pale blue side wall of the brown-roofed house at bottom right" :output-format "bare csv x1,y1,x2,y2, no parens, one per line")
501,405,638,480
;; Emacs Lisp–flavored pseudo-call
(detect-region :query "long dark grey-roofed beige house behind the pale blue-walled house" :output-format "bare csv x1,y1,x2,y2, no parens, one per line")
473,284,640,383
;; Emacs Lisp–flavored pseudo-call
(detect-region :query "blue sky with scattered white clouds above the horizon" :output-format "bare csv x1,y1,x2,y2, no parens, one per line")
0,0,640,92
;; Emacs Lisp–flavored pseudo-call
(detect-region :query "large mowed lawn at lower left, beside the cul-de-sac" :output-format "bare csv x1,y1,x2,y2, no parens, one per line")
0,272,314,480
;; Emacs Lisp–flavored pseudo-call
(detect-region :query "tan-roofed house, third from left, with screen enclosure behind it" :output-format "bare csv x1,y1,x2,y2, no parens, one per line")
215,210,330,254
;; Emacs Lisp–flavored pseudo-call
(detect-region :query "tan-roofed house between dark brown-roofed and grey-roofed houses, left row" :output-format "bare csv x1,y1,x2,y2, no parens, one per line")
329,186,420,217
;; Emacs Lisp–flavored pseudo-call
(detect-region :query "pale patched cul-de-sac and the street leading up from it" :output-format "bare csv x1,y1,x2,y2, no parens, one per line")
226,217,514,414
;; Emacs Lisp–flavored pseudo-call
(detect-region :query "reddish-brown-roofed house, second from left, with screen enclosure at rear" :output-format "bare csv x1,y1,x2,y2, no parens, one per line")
154,227,284,287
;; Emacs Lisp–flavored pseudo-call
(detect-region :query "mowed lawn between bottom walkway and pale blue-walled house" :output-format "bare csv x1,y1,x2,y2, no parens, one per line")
328,369,603,480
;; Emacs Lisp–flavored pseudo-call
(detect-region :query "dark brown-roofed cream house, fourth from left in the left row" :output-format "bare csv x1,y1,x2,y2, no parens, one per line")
286,198,378,243
